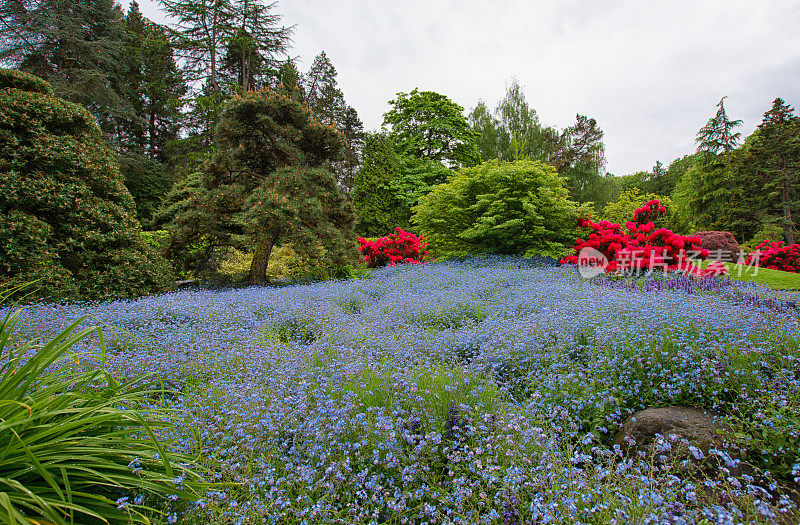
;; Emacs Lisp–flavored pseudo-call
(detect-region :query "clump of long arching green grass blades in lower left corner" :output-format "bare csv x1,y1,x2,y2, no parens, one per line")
0,288,197,525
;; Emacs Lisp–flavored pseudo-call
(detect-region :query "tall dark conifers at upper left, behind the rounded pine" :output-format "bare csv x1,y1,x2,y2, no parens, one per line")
0,0,363,223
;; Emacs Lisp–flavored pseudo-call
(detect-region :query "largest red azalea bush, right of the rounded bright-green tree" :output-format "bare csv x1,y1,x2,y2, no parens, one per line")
561,199,727,277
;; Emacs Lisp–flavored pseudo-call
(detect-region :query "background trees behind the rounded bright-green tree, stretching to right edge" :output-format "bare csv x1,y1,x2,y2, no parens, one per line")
354,81,800,250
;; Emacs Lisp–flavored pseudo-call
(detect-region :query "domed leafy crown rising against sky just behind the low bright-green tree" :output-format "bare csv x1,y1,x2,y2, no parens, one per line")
383,89,480,168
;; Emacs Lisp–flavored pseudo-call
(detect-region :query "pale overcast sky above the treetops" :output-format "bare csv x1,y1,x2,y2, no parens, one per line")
139,0,800,175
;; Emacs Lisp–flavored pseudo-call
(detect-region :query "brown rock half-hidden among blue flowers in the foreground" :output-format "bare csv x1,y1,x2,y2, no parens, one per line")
614,407,727,468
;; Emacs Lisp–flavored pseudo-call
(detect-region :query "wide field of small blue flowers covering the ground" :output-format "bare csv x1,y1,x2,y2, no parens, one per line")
10,257,800,524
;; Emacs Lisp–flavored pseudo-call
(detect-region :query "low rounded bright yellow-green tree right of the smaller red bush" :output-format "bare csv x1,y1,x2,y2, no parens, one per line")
413,160,588,257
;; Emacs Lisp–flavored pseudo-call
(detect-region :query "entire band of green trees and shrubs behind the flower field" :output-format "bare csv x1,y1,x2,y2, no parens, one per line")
0,0,800,298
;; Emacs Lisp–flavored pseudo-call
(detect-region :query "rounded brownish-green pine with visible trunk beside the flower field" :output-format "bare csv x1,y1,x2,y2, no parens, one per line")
175,90,355,284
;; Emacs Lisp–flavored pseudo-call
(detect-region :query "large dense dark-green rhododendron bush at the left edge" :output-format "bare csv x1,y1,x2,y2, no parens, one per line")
0,70,169,299
